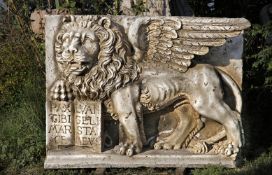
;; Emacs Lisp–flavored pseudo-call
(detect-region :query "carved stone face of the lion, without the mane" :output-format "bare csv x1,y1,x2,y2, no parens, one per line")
56,30,99,77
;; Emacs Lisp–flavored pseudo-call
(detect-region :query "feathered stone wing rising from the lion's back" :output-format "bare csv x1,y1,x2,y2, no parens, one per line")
128,17,250,72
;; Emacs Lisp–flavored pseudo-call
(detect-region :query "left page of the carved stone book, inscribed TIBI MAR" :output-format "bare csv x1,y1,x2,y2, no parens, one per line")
47,100,74,147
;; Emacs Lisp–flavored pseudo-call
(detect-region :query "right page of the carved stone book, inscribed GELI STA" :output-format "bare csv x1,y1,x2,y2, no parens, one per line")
75,101,102,152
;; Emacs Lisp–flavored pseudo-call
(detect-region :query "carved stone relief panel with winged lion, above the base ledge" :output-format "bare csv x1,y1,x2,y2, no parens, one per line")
46,16,250,167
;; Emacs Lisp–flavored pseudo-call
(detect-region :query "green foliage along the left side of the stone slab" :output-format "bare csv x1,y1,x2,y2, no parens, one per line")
0,0,45,174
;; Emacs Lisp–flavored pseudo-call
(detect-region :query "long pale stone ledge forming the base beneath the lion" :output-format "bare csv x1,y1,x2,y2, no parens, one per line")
44,148,237,169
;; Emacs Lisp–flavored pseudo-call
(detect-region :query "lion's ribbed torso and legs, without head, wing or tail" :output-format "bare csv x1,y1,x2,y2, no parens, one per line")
108,64,242,153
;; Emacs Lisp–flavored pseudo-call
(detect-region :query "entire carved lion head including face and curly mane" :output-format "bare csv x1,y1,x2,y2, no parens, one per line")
55,16,140,100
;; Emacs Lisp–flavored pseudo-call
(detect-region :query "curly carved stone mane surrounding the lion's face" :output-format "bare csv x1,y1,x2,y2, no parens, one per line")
55,16,141,100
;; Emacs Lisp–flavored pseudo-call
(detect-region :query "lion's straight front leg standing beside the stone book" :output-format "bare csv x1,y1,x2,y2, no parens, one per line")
111,84,145,156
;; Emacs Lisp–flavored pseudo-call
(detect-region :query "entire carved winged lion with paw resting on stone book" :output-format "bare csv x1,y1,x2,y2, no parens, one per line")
52,16,250,156
